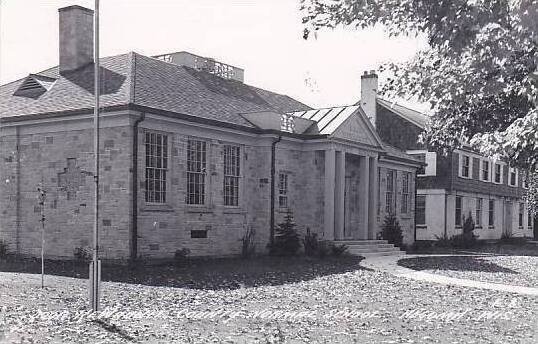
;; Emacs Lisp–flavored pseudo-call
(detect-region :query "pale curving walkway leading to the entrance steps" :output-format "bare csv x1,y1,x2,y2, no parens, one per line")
361,254,538,296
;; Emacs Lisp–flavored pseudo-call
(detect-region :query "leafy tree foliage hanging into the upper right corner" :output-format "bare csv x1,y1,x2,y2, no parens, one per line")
302,0,538,213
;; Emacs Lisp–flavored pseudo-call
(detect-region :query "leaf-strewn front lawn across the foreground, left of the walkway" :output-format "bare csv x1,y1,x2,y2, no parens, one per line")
0,257,538,343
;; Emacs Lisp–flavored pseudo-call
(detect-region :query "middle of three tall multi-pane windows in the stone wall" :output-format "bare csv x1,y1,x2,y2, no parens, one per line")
186,139,207,205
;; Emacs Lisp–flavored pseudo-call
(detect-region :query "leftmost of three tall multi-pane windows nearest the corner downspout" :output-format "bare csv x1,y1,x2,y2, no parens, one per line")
144,132,168,203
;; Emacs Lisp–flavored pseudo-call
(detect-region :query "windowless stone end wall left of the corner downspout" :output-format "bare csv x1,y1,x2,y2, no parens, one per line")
0,114,132,259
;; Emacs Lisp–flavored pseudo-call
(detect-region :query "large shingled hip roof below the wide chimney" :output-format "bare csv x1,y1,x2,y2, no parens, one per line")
0,52,310,127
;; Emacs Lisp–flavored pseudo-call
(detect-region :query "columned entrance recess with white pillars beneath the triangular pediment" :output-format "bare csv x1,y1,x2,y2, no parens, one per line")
324,148,378,240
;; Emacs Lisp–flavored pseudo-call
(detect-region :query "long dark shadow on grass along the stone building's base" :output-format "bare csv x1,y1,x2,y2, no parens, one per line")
0,256,366,290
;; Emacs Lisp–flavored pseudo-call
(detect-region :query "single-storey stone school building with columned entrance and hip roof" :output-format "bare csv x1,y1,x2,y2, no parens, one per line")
0,6,421,259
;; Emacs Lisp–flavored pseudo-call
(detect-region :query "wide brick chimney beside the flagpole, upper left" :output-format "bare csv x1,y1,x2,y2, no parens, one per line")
58,6,93,73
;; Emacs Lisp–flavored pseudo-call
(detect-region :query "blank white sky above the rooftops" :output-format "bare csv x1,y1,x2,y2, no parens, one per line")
0,0,426,107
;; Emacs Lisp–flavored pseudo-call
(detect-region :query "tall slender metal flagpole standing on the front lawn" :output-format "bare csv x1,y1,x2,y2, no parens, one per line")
92,0,100,312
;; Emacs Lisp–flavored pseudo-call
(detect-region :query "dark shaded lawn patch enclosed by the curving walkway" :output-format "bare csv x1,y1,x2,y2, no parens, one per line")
398,256,518,274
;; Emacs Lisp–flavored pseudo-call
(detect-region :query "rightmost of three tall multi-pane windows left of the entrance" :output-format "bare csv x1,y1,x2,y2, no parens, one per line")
224,145,241,206
